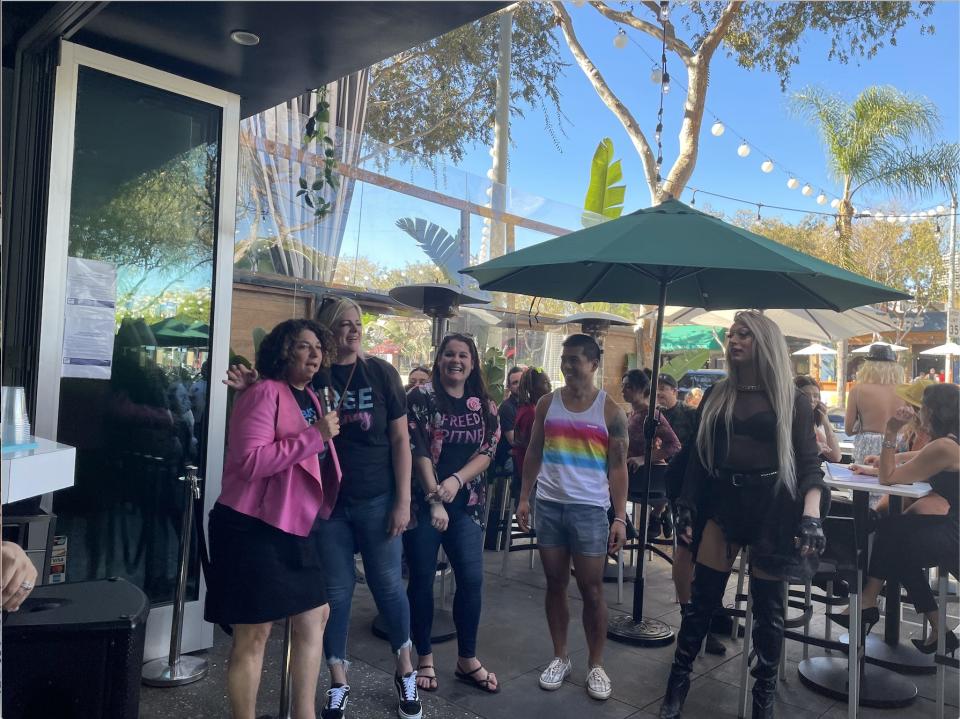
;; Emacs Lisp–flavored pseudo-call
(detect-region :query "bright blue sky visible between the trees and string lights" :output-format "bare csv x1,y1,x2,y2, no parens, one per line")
461,2,960,221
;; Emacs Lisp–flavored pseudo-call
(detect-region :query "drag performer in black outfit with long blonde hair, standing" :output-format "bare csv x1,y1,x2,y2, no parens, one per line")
660,312,829,719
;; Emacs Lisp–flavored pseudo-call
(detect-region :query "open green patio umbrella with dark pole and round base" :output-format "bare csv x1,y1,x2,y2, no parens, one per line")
461,200,910,646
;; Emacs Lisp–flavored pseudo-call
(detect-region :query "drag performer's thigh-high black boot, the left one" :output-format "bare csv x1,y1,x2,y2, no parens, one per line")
660,564,729,719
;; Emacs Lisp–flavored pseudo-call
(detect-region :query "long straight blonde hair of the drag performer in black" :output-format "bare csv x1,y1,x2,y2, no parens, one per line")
697,311,797,498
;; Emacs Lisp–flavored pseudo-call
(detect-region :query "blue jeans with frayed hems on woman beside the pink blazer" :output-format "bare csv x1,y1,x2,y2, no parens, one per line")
317,493,410,665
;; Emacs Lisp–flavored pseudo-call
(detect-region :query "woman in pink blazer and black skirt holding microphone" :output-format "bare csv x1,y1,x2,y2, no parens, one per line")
205,320,340,719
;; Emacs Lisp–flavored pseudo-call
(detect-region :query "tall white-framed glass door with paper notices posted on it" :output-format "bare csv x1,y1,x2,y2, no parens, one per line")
37,43,238,659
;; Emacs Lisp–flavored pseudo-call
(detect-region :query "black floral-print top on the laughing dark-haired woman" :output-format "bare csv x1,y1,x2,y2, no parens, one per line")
407,382,500,529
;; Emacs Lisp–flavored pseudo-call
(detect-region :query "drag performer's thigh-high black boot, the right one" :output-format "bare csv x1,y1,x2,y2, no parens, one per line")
750,577,784,719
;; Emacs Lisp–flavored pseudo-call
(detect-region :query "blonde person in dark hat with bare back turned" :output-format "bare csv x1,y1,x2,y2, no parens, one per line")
844,343,905,464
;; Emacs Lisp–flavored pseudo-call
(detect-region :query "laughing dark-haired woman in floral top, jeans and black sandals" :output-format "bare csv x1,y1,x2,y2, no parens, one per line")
403,334,500,693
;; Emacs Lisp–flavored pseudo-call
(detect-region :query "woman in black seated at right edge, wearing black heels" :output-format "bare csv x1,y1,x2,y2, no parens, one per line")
844,383,960,654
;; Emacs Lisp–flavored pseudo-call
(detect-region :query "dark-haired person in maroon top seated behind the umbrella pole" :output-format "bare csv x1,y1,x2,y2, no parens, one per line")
620,369,680,538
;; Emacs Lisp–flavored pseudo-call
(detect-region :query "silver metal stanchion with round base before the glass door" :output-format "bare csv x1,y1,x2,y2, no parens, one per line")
142,466,208,687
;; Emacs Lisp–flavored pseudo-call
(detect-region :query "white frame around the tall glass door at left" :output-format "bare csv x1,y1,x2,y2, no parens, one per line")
34,41,240,661
